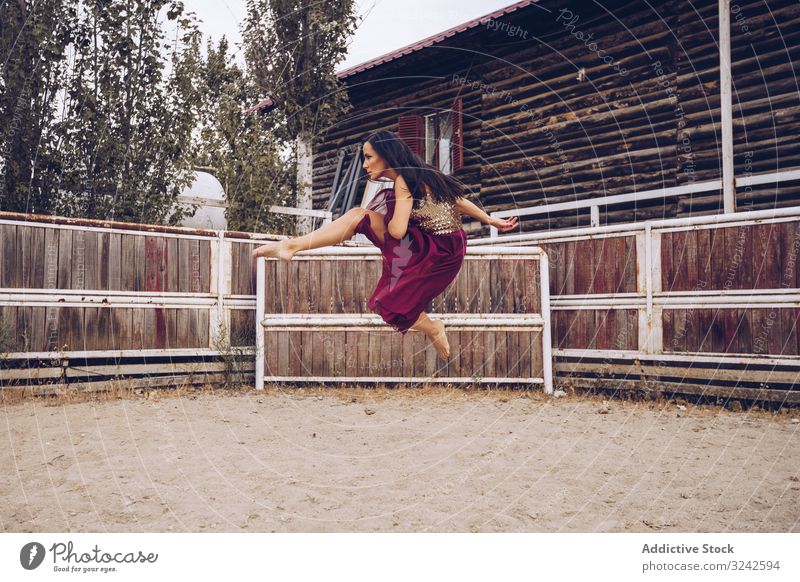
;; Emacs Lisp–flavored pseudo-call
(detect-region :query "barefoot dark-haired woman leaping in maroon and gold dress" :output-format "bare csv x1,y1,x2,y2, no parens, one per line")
253,131,517,359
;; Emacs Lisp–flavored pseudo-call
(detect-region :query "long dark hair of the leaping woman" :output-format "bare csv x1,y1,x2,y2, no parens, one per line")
366,131,464,203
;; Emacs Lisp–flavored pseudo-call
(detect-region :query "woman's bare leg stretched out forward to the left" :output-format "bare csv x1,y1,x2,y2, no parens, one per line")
253,208,386,261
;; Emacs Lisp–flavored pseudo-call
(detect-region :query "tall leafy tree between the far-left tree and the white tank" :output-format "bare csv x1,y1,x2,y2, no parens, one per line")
54,0,201,223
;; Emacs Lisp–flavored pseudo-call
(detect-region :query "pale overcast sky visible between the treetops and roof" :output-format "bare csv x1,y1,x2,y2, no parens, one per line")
189,0,515,71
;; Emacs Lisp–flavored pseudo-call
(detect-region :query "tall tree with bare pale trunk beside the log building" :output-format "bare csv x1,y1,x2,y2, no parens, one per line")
243,0,357,233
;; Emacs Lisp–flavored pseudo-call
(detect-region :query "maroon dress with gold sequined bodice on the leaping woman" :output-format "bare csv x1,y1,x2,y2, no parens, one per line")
356,188,467,334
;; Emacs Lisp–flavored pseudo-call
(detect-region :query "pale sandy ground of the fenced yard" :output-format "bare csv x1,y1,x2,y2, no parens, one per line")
0,387,800,532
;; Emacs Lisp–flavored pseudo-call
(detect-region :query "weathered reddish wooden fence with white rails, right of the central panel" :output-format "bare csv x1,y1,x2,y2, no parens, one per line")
471,207,800,403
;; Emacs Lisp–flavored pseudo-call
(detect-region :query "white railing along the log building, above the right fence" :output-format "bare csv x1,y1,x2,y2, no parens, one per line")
489,169,800,238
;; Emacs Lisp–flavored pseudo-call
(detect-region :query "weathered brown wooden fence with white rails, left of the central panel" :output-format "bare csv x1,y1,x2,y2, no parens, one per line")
0,213,280,390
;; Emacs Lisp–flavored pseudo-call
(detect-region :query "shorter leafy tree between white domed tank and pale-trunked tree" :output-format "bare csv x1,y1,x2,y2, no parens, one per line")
195,37,294,232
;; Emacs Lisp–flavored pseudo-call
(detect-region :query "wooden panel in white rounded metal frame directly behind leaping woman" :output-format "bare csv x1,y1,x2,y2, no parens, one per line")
256,247,552,393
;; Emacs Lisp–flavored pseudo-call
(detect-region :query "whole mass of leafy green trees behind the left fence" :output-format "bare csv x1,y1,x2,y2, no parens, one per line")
0,0,355,233
